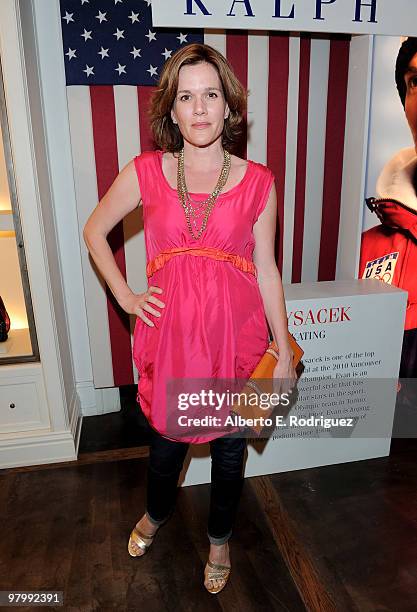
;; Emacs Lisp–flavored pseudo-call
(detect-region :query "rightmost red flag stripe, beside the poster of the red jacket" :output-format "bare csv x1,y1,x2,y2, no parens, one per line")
318,38,350,281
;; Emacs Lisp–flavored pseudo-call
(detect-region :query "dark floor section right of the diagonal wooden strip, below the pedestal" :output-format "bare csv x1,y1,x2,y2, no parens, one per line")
269,444,417,612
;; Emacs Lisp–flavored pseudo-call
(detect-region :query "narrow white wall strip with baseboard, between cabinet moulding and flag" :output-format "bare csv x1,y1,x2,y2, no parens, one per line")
27,0,120,415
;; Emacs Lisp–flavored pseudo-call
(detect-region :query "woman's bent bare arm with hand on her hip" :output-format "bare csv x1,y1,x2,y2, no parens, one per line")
83,161,165,325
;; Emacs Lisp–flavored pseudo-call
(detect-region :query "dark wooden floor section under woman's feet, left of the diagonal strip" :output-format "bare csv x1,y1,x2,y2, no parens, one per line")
0,459,305,612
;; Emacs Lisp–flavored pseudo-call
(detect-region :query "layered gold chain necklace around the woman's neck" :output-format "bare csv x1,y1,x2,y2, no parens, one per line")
177,148,231,240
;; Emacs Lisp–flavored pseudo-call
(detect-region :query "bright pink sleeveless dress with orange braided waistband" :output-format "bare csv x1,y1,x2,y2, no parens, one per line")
133,151,274,444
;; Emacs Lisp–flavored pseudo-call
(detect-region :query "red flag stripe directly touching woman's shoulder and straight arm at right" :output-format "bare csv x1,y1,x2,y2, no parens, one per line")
267,32,290,274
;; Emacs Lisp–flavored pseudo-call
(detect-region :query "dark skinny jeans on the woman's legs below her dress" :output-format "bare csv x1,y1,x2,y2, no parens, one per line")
146,429,246,544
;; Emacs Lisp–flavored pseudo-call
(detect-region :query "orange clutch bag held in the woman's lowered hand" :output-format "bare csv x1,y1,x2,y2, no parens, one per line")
231,332,304,435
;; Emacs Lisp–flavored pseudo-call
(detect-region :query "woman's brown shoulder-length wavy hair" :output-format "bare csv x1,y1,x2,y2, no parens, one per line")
149,43,247,153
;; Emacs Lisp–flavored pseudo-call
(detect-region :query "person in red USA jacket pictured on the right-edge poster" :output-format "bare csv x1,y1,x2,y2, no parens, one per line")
359,38,417,437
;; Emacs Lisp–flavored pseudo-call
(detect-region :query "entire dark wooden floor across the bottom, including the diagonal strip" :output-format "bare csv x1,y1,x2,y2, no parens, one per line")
0,390,417,612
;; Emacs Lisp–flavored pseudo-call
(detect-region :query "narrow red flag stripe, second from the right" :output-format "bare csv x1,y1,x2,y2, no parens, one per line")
292,35,311,283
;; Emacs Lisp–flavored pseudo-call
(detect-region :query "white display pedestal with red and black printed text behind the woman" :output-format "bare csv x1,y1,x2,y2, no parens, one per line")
182,280,407,486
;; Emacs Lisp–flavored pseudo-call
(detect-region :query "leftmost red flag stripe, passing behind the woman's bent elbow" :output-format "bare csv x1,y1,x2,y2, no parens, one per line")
90,85,134,387
